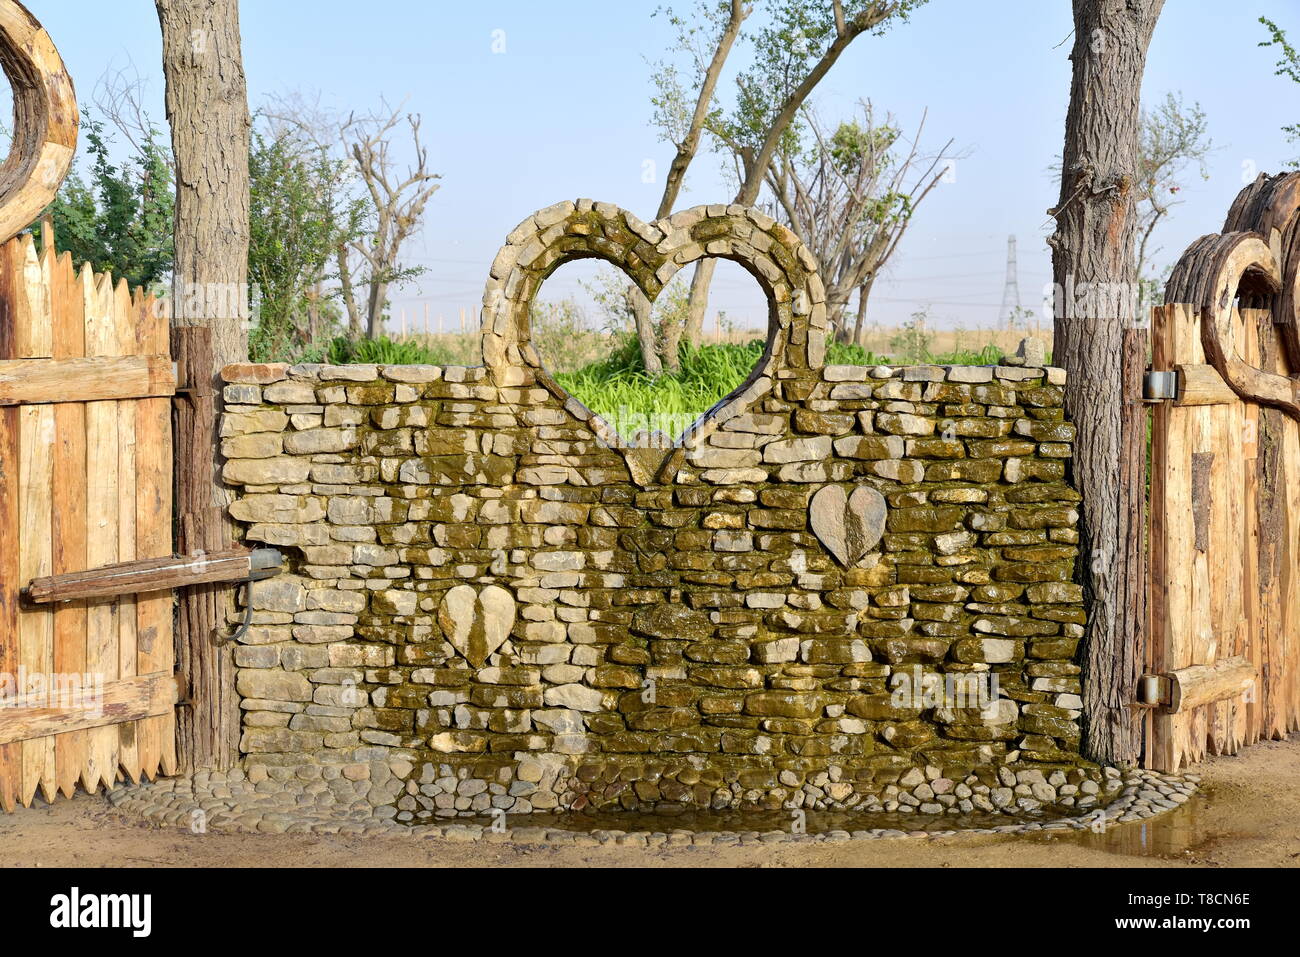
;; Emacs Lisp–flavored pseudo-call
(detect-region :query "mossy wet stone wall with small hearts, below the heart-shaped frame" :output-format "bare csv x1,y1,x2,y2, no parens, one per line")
221,356,1083,814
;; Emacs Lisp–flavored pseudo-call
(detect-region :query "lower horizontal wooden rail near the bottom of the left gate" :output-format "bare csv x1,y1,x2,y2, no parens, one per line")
0,675,181,744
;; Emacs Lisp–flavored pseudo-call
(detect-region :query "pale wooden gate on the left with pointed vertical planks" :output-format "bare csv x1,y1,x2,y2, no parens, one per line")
0,231,178,810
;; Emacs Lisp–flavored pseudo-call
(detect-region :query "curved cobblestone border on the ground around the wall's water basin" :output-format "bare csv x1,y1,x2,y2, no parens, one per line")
108,768,1200,846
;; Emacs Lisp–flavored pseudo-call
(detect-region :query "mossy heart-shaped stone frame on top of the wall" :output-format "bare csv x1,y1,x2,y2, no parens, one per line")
482,199,827,485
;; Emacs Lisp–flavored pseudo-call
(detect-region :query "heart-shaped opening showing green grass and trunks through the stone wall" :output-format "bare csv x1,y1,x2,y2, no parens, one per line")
529,259,770,449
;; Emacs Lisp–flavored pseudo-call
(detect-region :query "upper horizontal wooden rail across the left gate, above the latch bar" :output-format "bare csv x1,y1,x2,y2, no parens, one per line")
0,355,176,406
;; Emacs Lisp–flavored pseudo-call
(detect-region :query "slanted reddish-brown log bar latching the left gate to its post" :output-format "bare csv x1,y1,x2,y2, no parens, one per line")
23,547,280,605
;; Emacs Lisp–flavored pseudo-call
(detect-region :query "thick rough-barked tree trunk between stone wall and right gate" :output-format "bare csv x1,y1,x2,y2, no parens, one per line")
1048,0,1164,765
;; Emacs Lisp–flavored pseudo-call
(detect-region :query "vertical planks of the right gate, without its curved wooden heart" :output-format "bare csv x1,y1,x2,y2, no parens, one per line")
1147,304,1300,770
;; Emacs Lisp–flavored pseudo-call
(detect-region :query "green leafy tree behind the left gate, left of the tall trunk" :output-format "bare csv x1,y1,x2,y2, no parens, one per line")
46,113,176,289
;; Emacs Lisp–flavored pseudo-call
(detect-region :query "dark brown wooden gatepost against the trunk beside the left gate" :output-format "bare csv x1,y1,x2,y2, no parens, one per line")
172,326,239,771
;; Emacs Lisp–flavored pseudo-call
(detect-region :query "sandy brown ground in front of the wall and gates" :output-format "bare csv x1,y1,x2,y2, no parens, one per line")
0,736,1300,867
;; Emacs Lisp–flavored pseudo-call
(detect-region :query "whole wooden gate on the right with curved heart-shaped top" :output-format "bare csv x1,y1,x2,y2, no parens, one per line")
1140,173,1300,771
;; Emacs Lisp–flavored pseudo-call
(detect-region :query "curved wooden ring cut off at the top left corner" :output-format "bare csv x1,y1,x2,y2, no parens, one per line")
0,0,77,247
